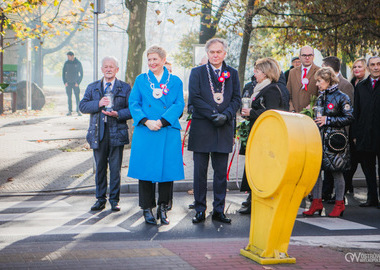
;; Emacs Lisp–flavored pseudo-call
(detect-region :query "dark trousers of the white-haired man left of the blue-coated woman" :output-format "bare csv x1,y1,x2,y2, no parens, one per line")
94,124,124,202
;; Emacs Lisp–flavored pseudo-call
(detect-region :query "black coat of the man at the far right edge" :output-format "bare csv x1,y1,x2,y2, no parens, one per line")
352,76,380,152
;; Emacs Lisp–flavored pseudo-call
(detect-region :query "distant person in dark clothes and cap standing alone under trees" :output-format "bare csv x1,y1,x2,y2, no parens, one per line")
62,51,83,116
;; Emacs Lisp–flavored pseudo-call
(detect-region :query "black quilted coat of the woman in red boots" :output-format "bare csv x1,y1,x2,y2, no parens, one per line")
316,86,353,171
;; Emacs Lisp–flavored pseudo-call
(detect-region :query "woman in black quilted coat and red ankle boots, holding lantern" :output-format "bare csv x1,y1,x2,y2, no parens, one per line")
303,67,354,217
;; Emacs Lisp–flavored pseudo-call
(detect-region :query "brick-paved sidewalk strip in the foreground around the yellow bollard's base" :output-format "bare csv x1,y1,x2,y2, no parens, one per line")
0,239,380,270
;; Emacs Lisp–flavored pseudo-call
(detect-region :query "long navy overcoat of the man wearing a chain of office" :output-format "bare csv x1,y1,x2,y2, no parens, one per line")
188,62,241,153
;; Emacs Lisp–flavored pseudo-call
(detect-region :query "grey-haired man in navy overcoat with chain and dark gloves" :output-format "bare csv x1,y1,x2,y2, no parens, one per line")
188,38,241,223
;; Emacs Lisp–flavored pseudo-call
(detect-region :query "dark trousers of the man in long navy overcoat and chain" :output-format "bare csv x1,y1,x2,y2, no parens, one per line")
193,152,228,213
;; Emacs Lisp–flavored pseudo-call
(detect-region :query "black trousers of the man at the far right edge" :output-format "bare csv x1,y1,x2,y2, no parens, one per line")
360,152,380,202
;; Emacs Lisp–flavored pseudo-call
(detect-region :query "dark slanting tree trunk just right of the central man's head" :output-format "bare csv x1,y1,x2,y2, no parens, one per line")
238,0,255,89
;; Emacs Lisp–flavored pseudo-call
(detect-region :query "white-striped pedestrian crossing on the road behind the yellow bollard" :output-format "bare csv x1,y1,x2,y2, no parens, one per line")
0,194,380,245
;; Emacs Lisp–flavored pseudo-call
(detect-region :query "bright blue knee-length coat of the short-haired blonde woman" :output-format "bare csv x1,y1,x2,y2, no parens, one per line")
128,68,185,183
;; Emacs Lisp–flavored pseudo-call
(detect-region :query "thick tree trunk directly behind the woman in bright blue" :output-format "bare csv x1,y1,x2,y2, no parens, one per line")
124,0,148,86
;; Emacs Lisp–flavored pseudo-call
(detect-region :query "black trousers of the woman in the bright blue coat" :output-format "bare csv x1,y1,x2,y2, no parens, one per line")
139,180,173,209
